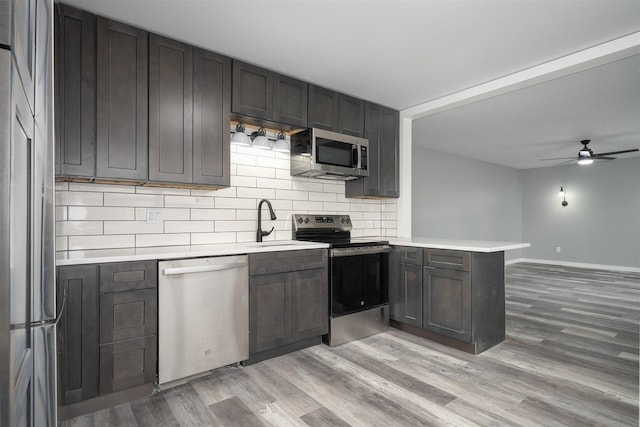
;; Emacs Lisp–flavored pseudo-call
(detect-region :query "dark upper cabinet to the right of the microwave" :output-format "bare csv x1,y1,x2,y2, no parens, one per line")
345,102,400,198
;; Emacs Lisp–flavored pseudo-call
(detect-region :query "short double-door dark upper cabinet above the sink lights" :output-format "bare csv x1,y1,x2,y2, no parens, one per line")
231,60,308,129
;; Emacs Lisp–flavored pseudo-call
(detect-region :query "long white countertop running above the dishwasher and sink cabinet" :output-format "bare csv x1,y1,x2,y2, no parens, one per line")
56,240,329,266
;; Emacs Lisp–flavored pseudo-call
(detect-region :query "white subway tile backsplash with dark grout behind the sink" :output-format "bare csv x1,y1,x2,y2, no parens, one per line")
55,146,398,253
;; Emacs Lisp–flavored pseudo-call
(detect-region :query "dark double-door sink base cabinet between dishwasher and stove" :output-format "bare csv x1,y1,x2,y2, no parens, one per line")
245,249,329,364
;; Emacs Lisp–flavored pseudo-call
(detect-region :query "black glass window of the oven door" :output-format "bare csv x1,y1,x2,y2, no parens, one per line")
331,253,389,317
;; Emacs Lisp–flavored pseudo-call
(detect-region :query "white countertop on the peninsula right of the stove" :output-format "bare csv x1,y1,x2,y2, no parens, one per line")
388,237,531,252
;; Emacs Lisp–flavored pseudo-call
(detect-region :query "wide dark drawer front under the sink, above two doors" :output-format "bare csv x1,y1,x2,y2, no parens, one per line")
249,249,328,276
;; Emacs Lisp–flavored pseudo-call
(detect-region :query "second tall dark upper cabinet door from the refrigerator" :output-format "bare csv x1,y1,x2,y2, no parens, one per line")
96,17,149,181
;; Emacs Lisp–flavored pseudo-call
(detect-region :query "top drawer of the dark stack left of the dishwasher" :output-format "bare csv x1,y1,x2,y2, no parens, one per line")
100,260,158,293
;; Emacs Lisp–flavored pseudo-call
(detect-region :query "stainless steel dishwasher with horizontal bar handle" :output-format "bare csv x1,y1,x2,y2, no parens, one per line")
158,255,249,385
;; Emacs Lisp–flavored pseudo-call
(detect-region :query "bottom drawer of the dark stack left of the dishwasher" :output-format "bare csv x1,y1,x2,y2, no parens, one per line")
100,335,157,394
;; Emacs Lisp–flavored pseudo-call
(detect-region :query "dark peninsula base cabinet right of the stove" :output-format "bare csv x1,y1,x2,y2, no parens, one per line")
390,247,505,354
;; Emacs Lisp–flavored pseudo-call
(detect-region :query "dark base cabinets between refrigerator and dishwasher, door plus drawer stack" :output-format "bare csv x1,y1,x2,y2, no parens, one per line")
57,261,158,408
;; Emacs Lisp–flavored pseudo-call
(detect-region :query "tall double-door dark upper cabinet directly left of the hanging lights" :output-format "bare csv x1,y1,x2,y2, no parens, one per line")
149,34,231,187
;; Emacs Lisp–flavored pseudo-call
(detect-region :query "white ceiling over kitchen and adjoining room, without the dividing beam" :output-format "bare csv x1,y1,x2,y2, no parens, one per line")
63,0,640,168
